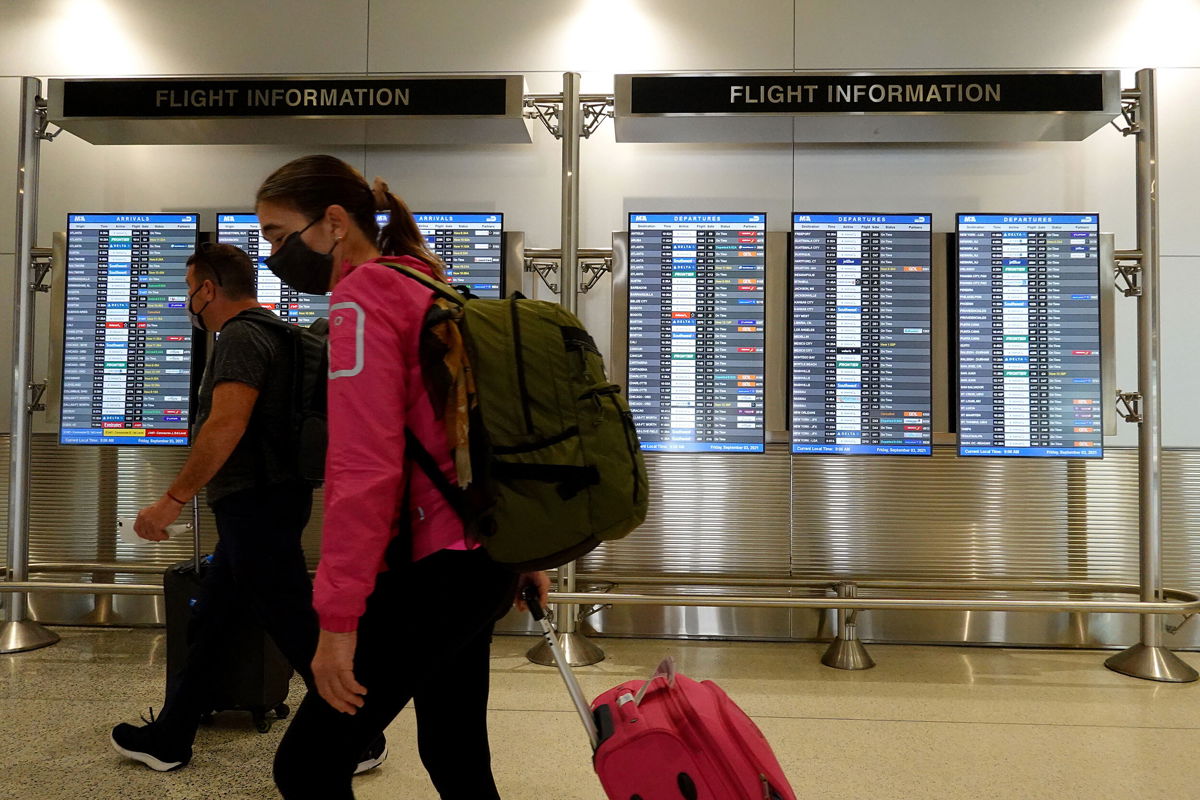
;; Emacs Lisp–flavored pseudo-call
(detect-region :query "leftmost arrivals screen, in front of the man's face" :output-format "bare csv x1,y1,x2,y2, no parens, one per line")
59,213,198,445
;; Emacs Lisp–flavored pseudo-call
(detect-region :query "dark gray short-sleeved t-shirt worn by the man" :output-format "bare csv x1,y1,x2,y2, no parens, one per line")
194,308,296,505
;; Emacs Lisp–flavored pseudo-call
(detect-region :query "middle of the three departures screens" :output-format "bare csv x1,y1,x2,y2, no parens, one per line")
792,213,934,456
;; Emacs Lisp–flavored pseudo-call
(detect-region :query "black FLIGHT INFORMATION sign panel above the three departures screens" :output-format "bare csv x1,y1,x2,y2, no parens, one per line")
629,72,1104,114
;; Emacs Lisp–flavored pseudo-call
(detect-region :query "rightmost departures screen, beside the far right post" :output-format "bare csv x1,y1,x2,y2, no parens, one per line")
958,213,1104,458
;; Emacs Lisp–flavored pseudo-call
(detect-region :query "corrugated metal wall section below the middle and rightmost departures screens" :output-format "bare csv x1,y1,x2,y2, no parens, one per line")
792,449,1200,588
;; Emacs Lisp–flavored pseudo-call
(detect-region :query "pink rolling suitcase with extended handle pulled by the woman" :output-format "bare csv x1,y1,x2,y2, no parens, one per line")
526,594,796,800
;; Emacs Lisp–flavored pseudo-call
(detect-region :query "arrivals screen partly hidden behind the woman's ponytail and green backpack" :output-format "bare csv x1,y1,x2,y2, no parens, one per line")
376,211,504,299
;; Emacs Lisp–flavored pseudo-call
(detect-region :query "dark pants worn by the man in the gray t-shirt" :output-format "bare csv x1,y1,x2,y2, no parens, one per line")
158,482,318,745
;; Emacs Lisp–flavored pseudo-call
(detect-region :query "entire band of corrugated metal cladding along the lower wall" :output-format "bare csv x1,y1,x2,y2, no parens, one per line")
0,435,1200,643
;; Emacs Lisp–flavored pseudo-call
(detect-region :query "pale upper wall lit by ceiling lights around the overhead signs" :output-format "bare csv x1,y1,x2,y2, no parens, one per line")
0,0,1200,446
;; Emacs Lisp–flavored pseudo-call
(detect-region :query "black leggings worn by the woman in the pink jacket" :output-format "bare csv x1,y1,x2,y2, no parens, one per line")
275,551,516,800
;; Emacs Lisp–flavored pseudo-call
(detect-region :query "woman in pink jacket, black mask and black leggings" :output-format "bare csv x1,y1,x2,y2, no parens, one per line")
257,156,548,800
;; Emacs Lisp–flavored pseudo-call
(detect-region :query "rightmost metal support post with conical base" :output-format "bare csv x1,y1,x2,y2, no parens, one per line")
1104,70,1200,684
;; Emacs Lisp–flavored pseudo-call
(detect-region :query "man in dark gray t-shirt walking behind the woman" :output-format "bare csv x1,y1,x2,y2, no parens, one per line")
112,245,386,771
